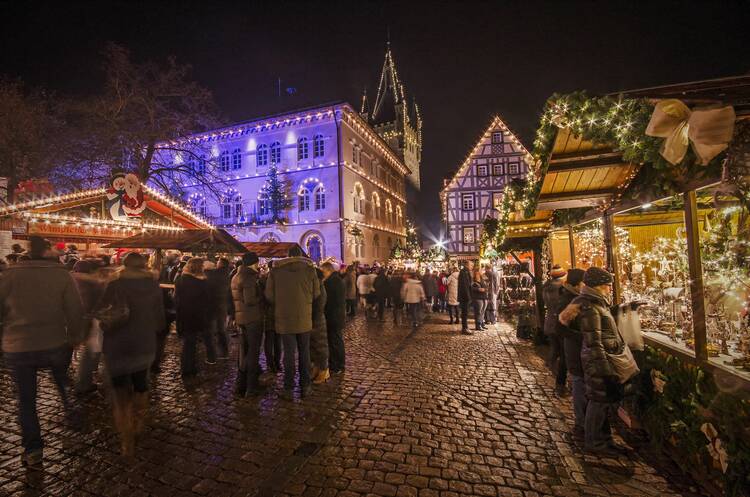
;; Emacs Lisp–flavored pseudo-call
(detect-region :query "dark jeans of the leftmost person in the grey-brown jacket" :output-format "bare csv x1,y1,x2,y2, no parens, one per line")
4,345,73,454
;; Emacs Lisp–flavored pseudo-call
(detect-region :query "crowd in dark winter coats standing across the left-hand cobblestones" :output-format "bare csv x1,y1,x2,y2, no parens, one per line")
0,236,346,467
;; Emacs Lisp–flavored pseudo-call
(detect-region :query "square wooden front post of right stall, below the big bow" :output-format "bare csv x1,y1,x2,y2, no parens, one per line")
682,190,708,361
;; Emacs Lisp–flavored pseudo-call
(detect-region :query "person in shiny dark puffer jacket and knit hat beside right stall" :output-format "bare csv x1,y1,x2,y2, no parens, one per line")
573,267,625,455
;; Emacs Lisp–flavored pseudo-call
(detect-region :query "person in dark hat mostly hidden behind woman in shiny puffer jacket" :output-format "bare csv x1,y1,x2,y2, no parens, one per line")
556,268,586,437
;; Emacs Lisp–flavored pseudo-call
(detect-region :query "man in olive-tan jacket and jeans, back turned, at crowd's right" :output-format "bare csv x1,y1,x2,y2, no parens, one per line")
265,246,320,400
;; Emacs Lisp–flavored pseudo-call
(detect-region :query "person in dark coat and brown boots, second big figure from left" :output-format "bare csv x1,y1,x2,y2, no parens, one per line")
98,252,165,456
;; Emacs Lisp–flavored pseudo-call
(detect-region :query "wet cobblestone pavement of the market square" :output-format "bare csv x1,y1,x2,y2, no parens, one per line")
0,316,701,497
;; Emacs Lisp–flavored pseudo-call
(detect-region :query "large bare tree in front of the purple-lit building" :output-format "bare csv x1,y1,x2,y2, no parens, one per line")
55,44,228,210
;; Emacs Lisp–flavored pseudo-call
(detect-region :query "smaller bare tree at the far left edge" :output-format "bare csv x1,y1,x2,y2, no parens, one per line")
0,80,59,203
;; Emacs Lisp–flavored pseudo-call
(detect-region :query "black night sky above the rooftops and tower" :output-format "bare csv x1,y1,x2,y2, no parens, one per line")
0,1,750,234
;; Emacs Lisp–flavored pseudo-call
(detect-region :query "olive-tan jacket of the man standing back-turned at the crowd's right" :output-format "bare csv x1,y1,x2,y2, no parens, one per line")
265,257,320,335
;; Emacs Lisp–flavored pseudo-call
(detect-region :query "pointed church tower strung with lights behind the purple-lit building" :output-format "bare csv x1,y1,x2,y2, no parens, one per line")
360,42,422,192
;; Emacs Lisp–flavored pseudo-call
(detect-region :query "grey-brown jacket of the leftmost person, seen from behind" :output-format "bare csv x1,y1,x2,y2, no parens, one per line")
0,260,83,353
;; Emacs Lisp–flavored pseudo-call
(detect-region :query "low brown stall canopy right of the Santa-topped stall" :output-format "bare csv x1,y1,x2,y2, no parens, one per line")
105,229,247,254
